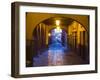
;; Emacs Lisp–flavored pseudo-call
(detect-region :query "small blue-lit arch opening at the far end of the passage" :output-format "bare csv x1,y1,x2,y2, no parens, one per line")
48,28,67,50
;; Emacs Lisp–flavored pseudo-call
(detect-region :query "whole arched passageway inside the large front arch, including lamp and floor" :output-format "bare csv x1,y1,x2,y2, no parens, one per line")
27,17,89,66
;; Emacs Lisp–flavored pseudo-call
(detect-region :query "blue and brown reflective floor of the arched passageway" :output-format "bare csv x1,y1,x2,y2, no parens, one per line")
33,44,84,67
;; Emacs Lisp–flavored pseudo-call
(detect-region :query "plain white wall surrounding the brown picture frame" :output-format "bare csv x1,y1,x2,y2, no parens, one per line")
0,0,100,80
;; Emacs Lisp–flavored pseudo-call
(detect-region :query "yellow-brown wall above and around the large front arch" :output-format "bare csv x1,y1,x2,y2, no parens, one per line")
26,12,88,40
